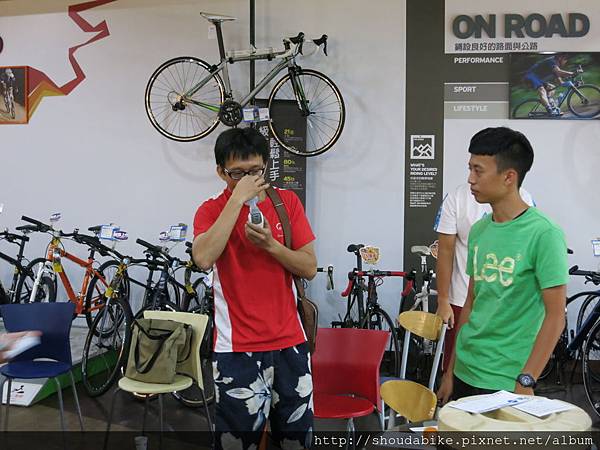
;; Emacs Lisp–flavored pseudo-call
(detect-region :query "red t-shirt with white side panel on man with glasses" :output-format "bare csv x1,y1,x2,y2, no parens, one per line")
194,189,315,353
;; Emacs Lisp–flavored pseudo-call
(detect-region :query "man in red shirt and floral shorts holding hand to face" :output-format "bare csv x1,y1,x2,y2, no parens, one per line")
192,128,317,448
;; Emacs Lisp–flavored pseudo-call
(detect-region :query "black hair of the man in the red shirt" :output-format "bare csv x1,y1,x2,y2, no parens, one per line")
215,128,269,167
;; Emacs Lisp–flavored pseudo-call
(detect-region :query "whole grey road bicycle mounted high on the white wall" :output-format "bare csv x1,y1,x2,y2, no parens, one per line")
145,13,345,156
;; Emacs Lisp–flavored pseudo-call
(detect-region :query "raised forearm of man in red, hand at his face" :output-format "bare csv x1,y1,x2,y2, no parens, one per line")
192,196,243,270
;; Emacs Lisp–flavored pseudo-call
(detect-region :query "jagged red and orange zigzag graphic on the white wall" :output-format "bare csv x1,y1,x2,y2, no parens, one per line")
29,0,116,117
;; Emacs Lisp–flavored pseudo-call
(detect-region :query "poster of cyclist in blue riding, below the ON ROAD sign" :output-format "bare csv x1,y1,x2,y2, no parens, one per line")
509,53,600,119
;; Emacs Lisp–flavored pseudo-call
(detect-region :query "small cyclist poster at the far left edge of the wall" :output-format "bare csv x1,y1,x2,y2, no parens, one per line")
0,66,29,124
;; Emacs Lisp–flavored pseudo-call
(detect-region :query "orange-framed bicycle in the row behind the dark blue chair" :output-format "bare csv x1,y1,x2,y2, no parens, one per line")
16,214,129,327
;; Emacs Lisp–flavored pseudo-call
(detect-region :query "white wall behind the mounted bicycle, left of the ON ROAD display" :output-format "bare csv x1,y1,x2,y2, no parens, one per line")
0,0,405,325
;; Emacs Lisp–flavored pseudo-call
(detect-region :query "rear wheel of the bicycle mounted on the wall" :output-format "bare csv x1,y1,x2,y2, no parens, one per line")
144,56,225,142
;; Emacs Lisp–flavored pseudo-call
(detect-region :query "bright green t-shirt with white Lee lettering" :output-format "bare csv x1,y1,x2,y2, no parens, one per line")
454,207,568,391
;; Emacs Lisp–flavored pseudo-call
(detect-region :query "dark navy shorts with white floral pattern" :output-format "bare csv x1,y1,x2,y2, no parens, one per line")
213,343,313,449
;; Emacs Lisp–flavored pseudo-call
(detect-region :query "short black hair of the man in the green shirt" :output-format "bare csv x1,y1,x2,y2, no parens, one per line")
469,127,533,187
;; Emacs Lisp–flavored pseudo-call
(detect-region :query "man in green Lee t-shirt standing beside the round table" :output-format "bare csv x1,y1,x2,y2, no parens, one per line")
437,127,568,403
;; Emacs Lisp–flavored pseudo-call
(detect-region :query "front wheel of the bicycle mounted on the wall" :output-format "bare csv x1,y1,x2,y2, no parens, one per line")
268,69,346,156
